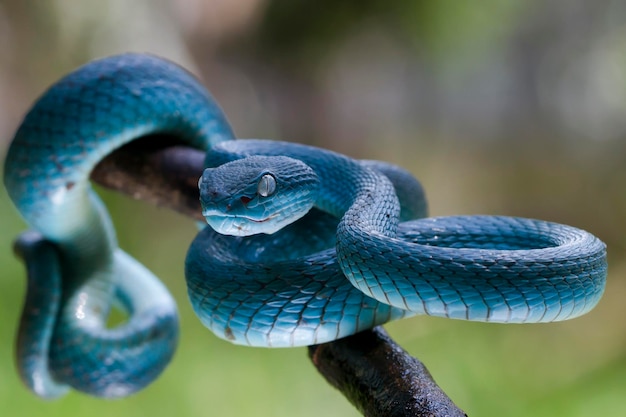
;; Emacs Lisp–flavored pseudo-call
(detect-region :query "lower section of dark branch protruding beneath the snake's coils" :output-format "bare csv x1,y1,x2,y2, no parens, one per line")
309,327,466,417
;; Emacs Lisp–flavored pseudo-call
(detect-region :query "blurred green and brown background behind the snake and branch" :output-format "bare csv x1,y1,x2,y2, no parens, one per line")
0,0,626,417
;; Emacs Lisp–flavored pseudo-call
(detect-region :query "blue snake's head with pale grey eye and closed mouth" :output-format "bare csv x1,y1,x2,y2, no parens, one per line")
198,156,319,236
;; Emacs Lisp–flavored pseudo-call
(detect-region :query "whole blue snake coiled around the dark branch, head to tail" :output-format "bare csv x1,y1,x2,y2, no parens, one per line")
4,54,607,397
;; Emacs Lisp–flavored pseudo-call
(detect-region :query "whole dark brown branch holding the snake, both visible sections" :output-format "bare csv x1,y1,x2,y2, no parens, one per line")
91,137,465,417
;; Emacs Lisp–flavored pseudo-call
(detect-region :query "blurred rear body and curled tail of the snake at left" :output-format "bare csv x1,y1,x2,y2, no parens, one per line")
4,55,233,397
